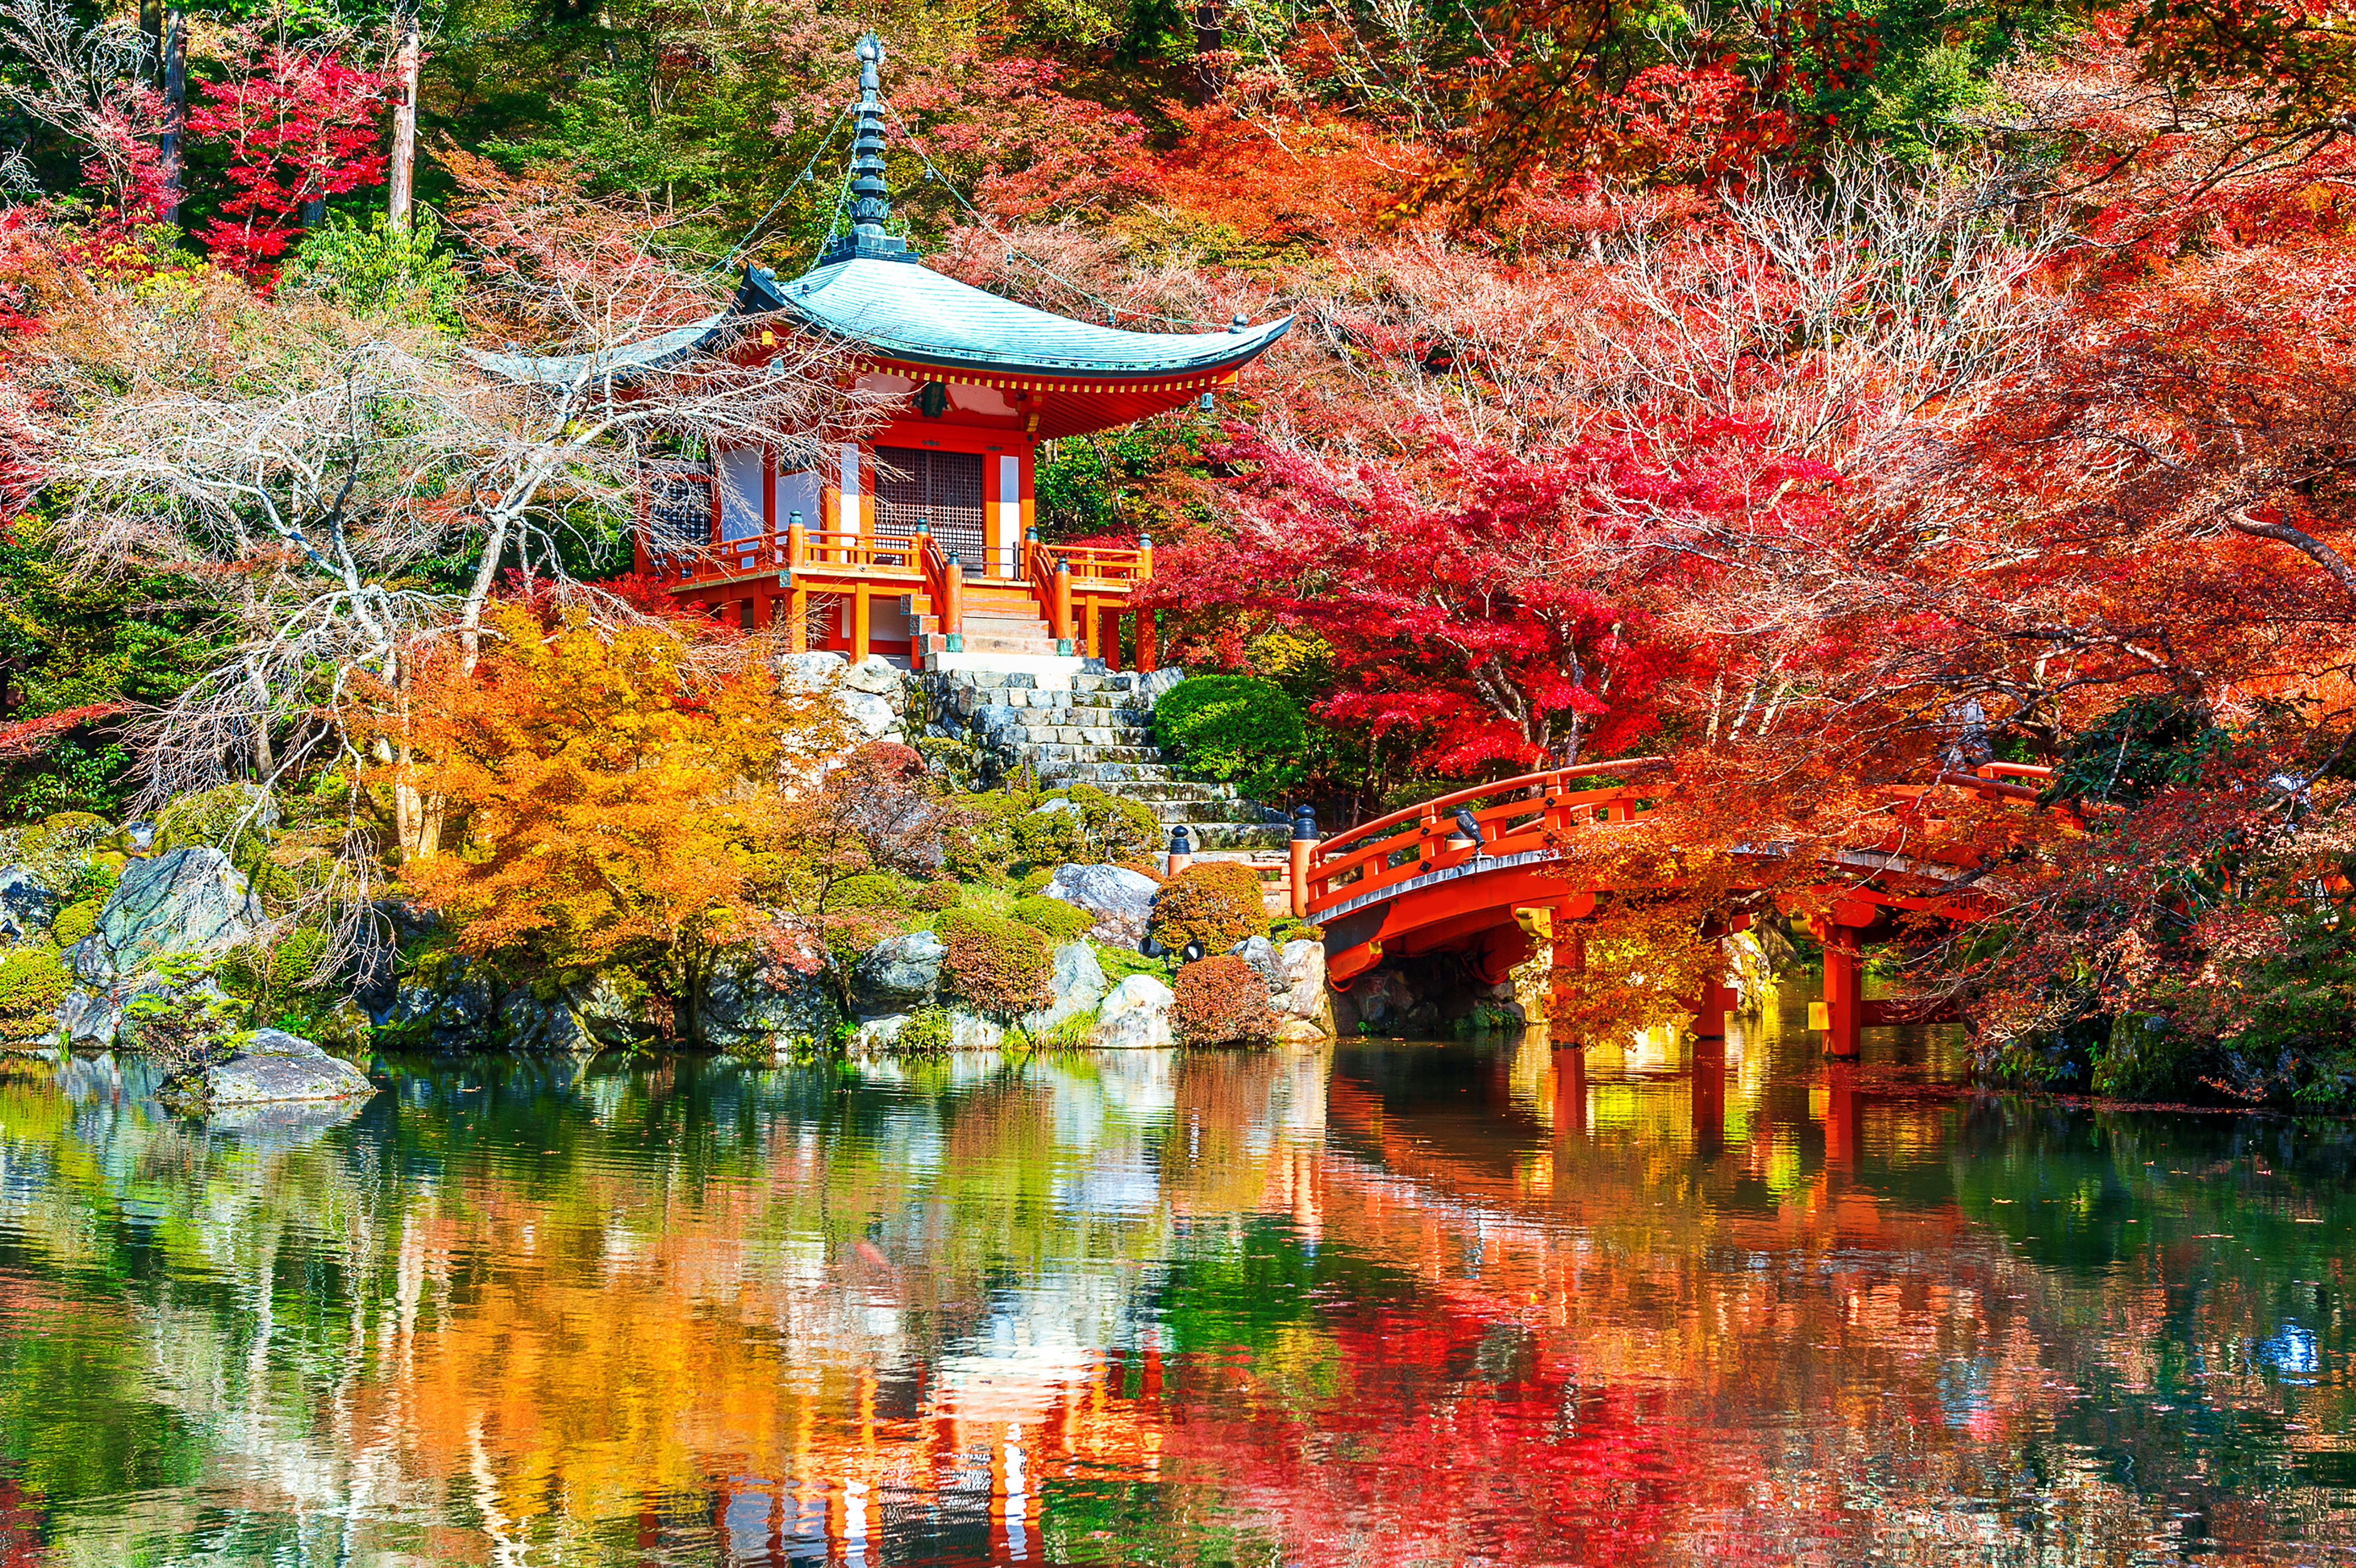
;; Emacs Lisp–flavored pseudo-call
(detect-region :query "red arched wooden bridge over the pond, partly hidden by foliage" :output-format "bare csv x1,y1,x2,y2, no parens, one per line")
1293,758,2052,1055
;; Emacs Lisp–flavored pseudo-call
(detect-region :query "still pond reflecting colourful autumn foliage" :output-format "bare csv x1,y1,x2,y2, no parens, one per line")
0,1015,2356,1568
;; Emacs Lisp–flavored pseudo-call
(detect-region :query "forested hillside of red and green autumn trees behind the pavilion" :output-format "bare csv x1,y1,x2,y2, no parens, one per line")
0,0,2356,1107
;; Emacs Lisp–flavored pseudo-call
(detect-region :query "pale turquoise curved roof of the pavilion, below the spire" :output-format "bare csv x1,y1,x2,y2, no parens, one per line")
737,257,1293,379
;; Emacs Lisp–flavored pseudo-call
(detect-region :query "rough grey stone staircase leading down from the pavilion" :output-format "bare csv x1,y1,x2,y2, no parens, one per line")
921,664,1291,857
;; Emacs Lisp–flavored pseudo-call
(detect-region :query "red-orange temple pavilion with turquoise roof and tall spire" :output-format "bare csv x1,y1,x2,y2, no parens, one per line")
617,35,1291,669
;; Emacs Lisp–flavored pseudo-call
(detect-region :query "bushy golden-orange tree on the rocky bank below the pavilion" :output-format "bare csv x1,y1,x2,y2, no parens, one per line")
401,605,841,1038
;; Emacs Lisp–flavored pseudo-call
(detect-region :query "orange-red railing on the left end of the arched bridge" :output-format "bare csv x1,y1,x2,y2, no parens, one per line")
1305,756,1663,921
